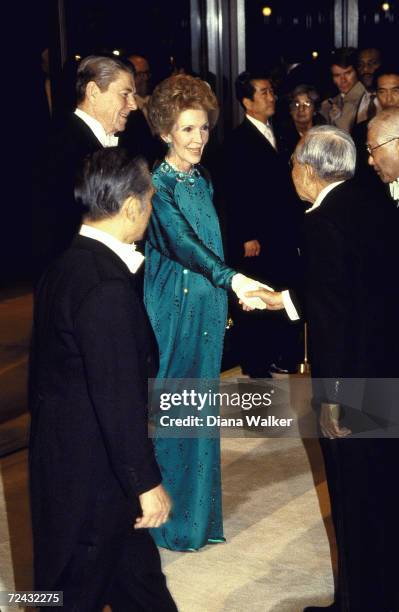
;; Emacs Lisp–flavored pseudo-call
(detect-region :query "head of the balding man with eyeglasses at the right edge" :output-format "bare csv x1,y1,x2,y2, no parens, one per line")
367,108,399,206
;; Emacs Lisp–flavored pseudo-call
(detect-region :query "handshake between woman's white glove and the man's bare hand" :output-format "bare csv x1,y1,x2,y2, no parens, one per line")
231,274,284,311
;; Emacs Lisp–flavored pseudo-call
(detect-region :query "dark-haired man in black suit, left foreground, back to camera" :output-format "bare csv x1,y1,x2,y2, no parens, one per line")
30,148,177,612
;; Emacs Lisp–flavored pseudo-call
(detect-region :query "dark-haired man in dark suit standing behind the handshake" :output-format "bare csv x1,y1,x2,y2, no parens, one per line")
224,72,301,378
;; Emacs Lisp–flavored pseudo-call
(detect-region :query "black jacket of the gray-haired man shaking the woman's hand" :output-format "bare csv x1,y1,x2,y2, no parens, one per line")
296,180,399,378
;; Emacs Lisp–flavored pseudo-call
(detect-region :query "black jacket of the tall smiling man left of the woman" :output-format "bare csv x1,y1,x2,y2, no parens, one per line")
33,113,103,268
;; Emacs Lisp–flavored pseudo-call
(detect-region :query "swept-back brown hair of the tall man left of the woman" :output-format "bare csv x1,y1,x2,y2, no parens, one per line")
76,55,134,104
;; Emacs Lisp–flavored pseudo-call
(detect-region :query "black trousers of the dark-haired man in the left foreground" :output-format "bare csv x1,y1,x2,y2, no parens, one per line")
43,526,177,612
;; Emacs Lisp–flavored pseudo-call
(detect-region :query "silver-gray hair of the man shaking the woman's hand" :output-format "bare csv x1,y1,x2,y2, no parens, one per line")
295,125,356,183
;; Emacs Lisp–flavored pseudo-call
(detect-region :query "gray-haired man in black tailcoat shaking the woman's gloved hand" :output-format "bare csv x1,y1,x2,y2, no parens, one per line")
249,125,399,612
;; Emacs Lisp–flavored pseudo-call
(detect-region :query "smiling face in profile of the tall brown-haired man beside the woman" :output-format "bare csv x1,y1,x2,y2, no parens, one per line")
94,70,137,134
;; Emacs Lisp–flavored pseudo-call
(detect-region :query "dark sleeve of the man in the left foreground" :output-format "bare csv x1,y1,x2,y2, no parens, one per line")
75,281,161,497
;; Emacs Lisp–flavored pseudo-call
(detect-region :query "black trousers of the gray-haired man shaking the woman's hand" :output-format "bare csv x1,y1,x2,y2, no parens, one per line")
320,437,399,612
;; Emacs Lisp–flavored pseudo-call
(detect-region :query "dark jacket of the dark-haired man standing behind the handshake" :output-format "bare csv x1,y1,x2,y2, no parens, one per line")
224,118,304,287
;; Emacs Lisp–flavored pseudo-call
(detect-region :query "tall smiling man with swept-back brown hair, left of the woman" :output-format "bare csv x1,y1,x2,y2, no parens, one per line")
33,56,136,276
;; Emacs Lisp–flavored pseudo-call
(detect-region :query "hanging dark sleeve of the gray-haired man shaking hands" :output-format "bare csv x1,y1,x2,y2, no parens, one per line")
305,219,353,378
